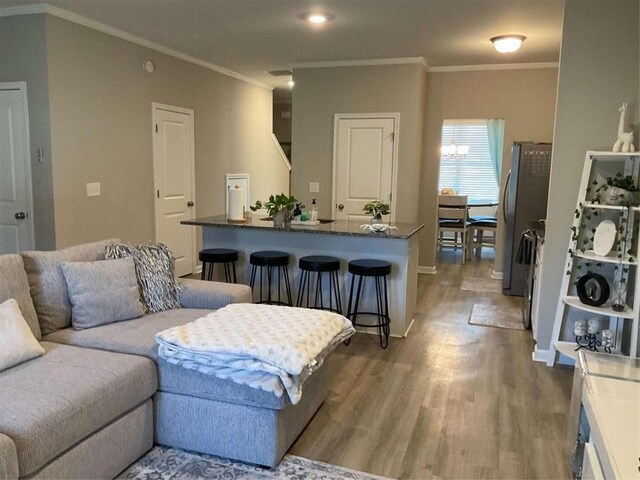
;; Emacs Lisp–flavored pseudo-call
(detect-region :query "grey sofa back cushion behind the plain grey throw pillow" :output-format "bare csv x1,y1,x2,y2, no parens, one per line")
22,240,118,335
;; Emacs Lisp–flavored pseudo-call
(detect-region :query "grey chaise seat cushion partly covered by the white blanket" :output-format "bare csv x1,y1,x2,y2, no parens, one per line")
45,308,288,409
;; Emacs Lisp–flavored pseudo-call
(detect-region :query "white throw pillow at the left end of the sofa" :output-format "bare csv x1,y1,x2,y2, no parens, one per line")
0,298,44,372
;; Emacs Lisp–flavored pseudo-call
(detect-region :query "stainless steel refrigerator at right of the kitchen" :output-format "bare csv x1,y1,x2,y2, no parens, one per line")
502,142,551,296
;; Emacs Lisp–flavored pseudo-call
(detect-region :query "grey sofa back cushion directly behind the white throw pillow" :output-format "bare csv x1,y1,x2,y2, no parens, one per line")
0,255,42,340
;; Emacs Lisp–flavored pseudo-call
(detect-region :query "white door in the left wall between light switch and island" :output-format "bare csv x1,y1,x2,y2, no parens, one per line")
153,103,196,277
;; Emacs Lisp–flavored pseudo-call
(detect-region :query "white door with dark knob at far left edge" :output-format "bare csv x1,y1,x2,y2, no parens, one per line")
0,83,33,254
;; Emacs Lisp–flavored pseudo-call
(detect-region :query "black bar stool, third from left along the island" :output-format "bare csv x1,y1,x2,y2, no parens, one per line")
296,255,342,315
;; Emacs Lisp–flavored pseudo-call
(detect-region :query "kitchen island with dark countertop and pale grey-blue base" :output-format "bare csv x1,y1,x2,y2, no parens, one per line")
181,215,424,337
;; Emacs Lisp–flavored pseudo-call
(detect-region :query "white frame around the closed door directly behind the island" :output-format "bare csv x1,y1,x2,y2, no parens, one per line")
331,112,400,222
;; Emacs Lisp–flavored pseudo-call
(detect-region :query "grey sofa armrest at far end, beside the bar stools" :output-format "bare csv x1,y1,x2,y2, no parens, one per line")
179,278,252,310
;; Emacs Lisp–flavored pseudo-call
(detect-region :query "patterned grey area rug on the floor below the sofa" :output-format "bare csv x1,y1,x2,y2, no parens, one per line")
118,447,390,480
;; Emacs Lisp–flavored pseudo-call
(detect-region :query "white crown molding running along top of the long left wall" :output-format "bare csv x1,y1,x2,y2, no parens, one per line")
0,3,273,90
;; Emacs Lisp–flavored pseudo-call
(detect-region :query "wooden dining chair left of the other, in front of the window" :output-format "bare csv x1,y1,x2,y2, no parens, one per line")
438,195,471,264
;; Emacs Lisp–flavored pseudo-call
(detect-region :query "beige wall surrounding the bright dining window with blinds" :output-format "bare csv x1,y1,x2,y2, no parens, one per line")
419,68,558,272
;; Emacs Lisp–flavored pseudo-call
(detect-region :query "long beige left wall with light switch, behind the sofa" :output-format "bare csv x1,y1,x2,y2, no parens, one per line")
41,15,289,248
